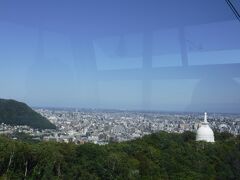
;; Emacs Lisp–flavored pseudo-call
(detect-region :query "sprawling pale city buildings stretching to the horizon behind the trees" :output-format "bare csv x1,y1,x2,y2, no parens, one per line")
0,108,240,145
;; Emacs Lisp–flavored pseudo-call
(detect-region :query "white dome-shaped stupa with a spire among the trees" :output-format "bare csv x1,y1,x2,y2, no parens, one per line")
196,112,214,142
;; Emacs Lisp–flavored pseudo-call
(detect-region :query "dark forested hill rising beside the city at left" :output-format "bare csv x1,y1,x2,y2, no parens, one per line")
0,99,56,129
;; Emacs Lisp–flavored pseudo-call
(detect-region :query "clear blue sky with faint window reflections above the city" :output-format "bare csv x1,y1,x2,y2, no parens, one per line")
0,0,240,113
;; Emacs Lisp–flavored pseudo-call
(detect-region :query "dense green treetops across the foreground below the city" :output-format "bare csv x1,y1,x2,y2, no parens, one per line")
0,132,240,180
